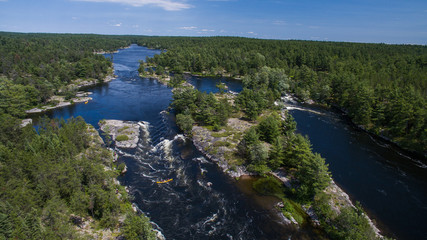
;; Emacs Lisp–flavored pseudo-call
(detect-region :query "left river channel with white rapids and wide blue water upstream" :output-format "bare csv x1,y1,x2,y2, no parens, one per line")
36,45,313,240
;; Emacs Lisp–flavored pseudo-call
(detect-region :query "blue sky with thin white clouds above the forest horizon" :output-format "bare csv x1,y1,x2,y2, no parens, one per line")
0,0,427,45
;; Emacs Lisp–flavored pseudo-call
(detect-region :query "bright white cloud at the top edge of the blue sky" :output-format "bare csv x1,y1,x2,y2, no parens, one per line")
73,0,193,11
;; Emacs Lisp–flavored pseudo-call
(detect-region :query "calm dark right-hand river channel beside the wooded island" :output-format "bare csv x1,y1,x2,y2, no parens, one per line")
291,106,427,240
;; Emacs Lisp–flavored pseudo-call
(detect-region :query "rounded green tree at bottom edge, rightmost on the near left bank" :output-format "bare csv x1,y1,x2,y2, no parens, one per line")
122,214,156,240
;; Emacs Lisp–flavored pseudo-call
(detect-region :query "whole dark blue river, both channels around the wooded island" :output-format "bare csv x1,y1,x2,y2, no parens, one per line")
35,45,427,239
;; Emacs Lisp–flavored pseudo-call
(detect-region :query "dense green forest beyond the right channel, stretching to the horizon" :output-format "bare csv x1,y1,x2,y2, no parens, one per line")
138,37,427,151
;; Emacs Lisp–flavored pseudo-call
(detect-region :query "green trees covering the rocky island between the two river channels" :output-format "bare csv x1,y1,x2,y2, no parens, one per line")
172,69,377,240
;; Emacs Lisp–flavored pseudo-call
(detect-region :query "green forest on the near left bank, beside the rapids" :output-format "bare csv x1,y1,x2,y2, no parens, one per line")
0,114,155,239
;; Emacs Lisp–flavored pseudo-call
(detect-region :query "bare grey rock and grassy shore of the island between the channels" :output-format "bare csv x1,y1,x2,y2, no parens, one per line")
184,88,383,238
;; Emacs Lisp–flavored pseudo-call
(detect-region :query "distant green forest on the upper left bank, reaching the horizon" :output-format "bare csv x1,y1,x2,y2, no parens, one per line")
0,32,134,116
